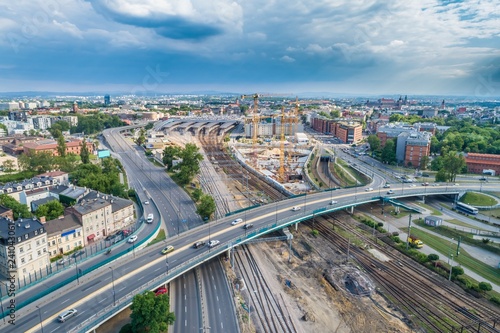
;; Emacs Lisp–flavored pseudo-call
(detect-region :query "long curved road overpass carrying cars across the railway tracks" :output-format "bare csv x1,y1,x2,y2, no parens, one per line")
0,185,468,332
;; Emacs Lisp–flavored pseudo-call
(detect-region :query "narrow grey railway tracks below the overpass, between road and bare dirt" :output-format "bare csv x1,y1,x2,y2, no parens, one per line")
233,245,297,333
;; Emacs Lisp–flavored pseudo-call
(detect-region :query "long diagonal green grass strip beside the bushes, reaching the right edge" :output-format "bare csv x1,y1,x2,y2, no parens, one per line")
411,229,500,285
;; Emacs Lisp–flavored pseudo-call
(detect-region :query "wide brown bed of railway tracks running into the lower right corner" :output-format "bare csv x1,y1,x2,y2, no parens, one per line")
308,215,500,332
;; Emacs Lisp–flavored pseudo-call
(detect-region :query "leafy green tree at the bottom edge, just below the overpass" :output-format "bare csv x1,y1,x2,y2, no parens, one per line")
130,291,175,333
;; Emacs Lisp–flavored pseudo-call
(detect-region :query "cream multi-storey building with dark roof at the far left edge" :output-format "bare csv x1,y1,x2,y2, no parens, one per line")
0,216,50,282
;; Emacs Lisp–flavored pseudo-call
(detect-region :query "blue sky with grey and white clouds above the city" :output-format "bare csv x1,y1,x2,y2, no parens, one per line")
0,0,500,98
